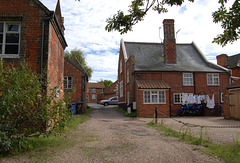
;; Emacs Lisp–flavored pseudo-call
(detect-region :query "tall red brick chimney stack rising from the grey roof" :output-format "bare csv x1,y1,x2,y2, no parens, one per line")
163,19,176,64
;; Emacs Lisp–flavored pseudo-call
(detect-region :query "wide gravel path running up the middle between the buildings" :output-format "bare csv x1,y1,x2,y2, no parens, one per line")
3,107,221,163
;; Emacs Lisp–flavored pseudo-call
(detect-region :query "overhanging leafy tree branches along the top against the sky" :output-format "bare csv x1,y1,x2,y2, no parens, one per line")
105,0,240,46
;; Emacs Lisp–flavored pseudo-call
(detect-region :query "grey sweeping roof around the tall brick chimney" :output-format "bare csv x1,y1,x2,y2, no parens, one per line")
121,42,228,72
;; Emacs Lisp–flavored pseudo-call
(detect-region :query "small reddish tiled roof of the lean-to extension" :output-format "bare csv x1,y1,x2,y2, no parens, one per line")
136,80,170,89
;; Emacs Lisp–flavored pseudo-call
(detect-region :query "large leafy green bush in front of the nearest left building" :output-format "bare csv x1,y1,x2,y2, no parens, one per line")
0,60,71,155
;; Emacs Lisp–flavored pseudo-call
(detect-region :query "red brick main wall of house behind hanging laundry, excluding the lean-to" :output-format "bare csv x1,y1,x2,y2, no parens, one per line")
135,72,229,115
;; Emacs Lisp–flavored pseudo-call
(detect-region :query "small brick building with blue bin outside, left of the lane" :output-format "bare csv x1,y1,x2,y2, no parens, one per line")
64,58,88,113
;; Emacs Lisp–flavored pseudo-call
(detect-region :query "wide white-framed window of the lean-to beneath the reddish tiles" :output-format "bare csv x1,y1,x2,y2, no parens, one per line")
143,90,166,104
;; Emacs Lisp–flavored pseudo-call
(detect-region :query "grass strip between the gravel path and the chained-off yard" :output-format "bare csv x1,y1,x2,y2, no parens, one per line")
148,122,240,163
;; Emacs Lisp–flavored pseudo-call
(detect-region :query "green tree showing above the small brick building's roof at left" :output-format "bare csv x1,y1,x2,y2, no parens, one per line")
64,48,93,78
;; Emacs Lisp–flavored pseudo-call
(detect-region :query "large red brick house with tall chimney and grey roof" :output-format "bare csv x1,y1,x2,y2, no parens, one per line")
118,19,229,117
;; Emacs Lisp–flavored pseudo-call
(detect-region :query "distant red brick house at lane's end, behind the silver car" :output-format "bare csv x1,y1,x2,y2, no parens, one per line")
87,83,105,103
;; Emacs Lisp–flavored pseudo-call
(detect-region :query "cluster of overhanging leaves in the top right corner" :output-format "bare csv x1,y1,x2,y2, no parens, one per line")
212,0,240,46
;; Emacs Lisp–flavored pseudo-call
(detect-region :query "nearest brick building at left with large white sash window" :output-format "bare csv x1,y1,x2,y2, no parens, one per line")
0,0,67,101
